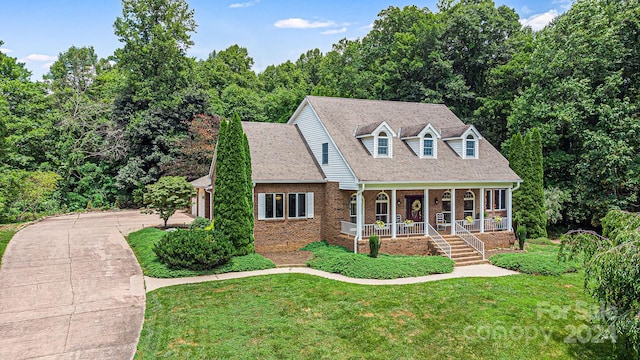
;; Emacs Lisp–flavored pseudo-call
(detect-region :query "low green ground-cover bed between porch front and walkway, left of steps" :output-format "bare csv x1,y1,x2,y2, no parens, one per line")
302,241,454,279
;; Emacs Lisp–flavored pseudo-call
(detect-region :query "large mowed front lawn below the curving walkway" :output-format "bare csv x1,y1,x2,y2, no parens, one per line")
136,273,612,359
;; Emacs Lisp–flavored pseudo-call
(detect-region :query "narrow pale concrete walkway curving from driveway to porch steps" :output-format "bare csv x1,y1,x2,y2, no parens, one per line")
144,264,519,292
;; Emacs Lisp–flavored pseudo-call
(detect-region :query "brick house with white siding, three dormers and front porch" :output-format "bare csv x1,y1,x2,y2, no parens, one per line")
194,96,522,262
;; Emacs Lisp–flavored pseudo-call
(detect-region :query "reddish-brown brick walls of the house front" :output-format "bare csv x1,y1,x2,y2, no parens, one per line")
248,182,515,255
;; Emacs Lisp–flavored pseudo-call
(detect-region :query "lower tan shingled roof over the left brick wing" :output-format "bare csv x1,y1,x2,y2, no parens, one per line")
242,122,325,183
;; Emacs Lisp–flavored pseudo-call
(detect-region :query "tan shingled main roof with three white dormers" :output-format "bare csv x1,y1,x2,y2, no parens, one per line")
298,96,521,183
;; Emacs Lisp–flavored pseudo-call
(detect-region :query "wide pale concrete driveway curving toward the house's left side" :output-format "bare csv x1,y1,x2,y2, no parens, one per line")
0,211,192,359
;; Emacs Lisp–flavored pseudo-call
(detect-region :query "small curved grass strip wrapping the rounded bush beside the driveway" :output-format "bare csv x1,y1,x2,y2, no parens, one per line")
127,228,275,278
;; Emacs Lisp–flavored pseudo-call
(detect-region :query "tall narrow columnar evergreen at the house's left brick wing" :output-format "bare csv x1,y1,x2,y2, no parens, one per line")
213,114,254,255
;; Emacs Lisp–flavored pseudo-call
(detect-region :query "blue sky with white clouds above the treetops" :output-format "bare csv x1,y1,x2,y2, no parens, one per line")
0,0,572,80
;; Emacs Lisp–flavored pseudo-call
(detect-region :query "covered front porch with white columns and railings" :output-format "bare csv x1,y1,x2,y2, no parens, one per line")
341,184,512,240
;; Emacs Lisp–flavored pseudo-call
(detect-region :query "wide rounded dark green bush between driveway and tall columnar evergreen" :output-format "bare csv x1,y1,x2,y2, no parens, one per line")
153,229,233,270
